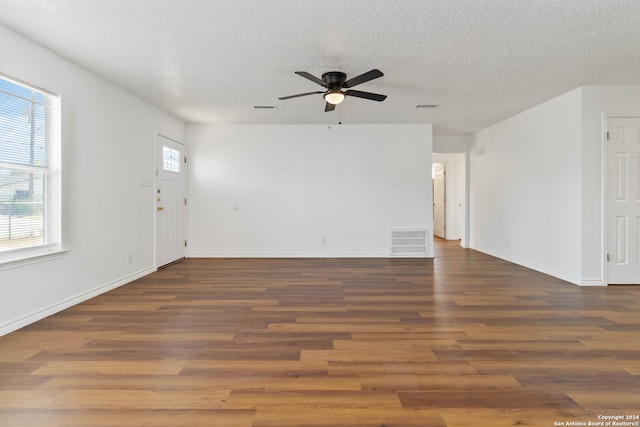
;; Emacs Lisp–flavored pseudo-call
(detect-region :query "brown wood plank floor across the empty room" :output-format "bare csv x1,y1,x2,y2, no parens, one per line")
0,241,640,427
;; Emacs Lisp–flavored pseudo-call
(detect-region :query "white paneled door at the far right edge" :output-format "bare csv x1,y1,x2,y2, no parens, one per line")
606,118,640,284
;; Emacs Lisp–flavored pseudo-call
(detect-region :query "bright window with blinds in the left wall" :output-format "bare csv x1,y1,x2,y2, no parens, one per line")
0,75,60,261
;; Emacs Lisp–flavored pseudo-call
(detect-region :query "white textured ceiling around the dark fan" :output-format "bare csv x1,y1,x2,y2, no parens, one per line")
0,0,640,134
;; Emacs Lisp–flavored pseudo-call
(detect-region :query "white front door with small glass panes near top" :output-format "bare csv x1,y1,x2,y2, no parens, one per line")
155,135,186,267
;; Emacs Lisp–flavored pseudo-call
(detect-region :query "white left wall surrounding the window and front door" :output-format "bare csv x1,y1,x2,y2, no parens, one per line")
0,26,186,335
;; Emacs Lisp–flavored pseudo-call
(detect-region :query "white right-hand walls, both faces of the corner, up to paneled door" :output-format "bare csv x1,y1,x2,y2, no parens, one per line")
470,86,640,285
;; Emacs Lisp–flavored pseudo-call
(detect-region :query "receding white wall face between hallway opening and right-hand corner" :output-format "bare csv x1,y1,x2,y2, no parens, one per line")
470,89,583,283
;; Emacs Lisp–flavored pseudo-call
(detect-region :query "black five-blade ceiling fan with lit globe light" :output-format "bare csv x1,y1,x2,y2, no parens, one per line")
278,68,387,111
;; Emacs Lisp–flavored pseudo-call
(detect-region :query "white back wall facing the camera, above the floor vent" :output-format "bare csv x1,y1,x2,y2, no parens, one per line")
188,125,433,257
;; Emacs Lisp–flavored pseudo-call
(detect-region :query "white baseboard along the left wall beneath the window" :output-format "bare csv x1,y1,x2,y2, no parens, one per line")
0,267,157,336
